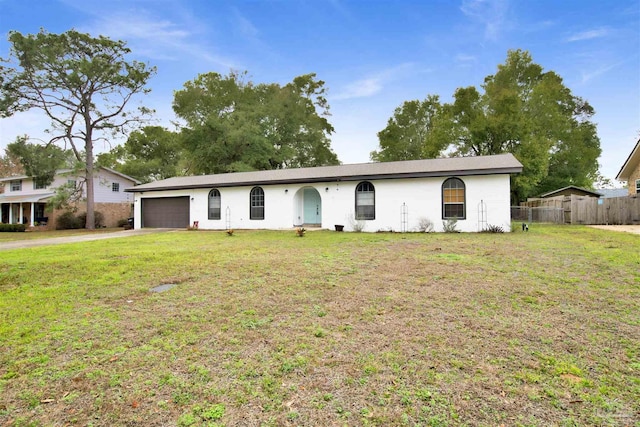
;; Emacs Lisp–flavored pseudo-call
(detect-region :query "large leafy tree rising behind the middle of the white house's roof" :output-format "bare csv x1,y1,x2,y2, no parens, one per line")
173,72,338,173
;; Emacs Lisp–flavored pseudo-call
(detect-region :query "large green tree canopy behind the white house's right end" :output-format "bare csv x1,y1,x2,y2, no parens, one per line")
371,50,601,202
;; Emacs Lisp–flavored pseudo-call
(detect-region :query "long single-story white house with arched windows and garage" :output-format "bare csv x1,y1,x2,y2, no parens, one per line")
127,154,522,232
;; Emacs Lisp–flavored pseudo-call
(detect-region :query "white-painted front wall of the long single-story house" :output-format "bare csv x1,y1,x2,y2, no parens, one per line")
134,175,511,232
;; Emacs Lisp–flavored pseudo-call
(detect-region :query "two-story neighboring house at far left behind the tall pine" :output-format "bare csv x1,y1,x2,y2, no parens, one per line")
0,168,139,227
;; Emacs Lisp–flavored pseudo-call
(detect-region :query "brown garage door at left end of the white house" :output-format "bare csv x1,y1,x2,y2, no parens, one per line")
142,197,189,228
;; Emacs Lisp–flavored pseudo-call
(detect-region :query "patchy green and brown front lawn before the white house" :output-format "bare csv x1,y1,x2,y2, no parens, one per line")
0,226,640,426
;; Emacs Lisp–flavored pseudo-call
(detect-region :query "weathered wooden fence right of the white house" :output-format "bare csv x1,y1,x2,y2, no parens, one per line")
521,195,640,225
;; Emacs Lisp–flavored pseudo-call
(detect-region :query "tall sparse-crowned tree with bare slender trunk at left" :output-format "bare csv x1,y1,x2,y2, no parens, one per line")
0,30,155,229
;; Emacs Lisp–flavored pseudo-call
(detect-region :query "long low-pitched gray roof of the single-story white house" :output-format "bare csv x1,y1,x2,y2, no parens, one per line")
126,154,522,192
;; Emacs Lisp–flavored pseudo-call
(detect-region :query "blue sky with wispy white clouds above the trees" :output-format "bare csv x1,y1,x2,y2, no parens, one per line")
0,0,640,182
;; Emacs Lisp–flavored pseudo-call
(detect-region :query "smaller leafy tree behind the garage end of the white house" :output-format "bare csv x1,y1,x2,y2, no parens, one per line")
98,126,186,183
